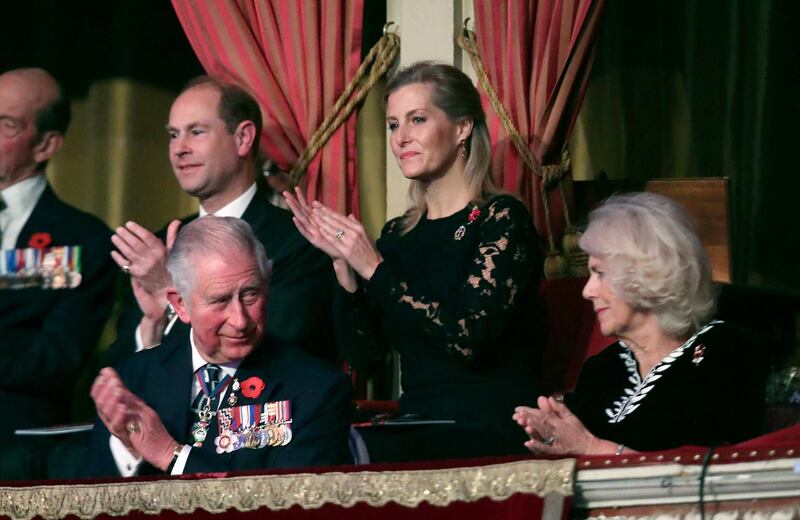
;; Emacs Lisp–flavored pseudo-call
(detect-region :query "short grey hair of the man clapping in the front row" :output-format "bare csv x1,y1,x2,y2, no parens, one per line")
167,215,272,303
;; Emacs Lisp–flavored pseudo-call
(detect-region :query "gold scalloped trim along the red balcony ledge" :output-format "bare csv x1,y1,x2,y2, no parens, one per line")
0,459,575,520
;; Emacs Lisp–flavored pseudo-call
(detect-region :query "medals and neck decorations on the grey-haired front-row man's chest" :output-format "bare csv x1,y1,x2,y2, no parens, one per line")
192,372,292,453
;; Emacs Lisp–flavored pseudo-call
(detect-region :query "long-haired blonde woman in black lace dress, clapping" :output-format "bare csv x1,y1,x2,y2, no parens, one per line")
286,62,541,462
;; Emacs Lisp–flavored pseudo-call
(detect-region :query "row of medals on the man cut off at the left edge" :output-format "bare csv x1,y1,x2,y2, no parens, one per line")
0,246,81,289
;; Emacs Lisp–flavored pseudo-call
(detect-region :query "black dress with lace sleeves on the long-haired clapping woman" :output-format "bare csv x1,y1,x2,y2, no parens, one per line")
340,195,544,461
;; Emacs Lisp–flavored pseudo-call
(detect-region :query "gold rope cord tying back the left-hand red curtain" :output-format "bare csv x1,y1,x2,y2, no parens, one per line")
289,22,400,186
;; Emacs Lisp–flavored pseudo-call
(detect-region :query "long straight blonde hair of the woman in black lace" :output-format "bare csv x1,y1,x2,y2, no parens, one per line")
383,61,500,233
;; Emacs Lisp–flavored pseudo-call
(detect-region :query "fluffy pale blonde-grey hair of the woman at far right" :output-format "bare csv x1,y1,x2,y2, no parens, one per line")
580,193,716,338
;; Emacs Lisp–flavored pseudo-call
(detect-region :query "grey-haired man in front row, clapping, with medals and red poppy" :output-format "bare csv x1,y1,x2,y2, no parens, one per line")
89,216,350,476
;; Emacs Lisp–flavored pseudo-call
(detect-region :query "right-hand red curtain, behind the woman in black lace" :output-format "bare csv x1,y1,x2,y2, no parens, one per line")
474,0,605,240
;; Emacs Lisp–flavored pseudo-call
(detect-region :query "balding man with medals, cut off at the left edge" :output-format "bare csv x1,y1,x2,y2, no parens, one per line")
0,69,116,479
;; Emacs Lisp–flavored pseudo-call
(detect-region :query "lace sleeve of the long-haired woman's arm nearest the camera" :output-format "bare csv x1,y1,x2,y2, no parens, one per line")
366,196,539,363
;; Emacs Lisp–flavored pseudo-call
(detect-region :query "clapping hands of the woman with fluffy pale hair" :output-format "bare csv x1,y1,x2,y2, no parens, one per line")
512,396,600,455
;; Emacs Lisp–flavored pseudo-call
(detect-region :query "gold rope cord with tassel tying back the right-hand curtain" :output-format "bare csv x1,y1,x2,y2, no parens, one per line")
458,23,575,278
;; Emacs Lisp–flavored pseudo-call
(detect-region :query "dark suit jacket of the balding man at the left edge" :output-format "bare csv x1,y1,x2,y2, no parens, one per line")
0,185,117,437
